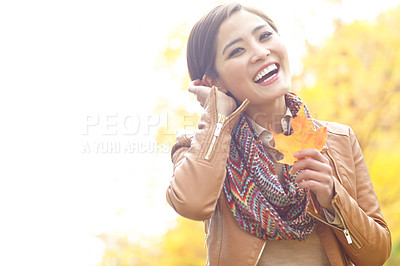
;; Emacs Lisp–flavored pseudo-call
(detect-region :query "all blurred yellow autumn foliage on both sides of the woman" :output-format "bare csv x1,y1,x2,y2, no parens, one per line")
101,3,400,266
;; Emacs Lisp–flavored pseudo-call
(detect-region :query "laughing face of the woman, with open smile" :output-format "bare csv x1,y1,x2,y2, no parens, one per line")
215,10,291,105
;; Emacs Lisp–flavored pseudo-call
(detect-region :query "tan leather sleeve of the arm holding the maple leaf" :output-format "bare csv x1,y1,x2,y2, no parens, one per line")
332,128,391,265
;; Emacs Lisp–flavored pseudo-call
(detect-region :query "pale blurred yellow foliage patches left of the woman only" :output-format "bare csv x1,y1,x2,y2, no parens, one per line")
95,20,207,266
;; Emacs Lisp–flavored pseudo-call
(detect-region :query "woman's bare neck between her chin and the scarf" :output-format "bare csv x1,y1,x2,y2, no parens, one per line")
246,96,286,133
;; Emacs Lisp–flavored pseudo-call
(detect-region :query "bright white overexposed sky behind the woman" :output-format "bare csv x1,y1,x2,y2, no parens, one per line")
0,0,400,266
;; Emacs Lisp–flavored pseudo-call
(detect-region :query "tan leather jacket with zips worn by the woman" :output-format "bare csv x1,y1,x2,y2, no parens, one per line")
167,90,391,266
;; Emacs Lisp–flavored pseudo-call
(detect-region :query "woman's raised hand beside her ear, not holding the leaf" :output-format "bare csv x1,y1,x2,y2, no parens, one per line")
188,79,237,116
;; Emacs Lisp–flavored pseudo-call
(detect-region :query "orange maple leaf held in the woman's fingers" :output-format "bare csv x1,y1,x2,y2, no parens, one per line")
271,105,328,165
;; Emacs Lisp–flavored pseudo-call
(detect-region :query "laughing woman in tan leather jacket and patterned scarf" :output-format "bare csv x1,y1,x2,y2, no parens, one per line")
167,4,391,266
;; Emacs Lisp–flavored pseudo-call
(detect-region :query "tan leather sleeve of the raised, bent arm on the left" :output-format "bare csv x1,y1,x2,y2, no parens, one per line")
166,89,248,220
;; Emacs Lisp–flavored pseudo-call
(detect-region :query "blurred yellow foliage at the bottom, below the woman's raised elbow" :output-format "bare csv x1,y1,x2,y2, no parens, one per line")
99,217,207,266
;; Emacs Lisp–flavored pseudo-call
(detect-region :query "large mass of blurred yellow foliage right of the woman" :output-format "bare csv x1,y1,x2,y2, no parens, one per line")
293,7,400,265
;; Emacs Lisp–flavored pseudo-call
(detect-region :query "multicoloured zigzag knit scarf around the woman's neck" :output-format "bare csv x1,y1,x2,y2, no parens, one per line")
223,92,314,240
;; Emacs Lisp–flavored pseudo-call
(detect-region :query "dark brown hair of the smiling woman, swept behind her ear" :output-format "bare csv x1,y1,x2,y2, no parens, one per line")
187,3,278,80
